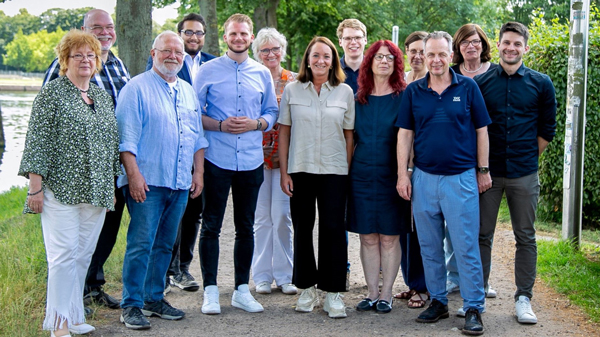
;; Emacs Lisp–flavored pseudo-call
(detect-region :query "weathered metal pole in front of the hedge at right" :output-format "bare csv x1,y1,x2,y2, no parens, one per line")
562,0,590,248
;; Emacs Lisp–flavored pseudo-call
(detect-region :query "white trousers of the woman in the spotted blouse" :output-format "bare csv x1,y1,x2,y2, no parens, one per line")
41,189,106,331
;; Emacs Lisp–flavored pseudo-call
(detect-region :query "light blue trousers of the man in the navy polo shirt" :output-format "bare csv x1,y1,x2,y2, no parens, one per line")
412,168,485,312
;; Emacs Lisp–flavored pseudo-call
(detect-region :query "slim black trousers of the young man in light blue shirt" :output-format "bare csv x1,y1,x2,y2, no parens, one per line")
199,160,264,289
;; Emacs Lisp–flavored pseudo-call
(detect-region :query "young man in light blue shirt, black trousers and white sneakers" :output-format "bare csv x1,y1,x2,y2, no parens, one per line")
194,14,278,314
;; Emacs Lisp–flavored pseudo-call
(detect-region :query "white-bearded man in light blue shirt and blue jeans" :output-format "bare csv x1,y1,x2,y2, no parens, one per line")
116,31,208,329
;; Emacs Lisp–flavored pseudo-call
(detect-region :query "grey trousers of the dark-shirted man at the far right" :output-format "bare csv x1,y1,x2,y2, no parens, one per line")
479,172,540,301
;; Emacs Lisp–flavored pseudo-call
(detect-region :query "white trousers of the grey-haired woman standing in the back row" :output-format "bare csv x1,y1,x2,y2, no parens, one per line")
252,169,294,286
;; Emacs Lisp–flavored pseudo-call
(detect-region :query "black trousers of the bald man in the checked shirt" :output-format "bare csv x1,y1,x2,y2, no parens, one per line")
83,178,125,294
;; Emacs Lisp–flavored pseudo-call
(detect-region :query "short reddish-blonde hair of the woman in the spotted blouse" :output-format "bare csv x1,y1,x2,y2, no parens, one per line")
54,29,102,76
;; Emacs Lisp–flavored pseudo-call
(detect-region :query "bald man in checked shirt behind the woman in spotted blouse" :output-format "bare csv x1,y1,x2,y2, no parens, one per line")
44,9,130,314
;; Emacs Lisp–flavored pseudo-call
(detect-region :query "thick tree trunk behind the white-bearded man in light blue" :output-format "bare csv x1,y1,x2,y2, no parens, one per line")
115,0,152,77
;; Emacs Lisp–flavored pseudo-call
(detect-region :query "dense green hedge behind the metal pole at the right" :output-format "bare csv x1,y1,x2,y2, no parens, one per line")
524,9,600,228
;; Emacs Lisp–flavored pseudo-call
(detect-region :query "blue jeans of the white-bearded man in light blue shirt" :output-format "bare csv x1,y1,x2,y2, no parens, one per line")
121,186,189,308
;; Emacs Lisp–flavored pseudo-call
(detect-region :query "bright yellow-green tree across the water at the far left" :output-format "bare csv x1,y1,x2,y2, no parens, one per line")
4,27,64,72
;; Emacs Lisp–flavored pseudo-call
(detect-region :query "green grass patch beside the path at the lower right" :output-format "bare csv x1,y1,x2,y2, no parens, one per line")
537,240,600,323
